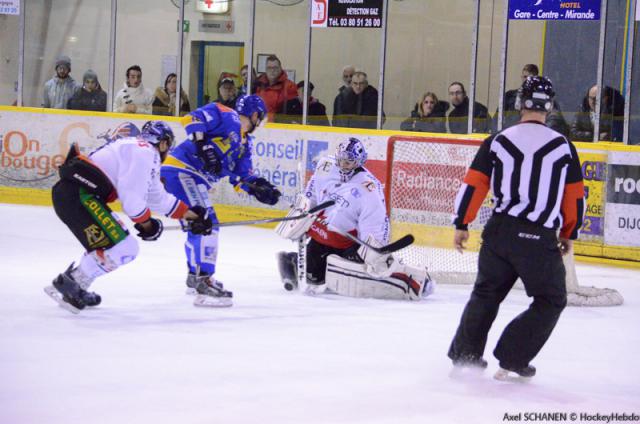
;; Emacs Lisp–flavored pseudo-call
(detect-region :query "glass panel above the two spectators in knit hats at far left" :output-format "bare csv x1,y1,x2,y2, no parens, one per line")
22,0,111,107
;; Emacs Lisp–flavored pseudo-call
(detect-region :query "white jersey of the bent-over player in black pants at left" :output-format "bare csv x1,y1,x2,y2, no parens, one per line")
89,137,188,222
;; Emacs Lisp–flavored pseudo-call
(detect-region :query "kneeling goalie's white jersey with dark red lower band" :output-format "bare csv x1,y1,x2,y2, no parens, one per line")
305,157,389,249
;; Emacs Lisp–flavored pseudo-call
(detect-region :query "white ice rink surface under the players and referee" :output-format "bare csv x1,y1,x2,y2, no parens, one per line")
0,204,640,424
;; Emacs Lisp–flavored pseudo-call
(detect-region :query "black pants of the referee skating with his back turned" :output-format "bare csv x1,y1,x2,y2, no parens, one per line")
449,215,567,368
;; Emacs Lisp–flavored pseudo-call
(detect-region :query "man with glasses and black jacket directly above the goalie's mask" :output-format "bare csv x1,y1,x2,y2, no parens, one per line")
333,71,384,129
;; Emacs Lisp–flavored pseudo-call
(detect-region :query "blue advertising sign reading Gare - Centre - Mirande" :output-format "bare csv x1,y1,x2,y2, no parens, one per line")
509,0,601,21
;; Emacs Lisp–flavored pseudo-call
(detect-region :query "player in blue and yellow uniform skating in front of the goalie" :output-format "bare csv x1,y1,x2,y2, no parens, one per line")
161,95,281,306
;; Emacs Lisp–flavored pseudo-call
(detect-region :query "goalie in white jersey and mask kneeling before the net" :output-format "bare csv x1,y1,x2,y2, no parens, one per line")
276,137,434,300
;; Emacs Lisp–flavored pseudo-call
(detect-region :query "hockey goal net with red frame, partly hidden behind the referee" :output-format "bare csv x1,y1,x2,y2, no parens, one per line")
385,136,622,306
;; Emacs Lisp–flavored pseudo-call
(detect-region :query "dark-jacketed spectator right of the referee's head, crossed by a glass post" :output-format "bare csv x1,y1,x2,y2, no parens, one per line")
571,85,624,141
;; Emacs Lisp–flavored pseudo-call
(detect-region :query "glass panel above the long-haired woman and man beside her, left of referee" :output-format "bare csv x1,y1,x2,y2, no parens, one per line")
383,0,475,130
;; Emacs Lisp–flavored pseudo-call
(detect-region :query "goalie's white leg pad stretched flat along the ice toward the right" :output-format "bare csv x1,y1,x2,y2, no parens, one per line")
326,255,433,300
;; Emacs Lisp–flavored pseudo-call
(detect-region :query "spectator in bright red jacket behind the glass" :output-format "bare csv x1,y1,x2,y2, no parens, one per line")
256,55,298,122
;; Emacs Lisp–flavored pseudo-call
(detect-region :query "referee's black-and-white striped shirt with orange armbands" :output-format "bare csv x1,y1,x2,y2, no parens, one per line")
453,121,584,239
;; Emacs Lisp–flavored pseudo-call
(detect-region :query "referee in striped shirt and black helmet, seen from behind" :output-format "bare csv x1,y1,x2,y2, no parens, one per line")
449,76,584,378
